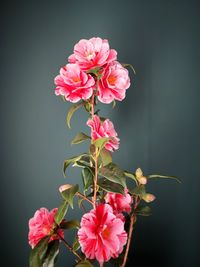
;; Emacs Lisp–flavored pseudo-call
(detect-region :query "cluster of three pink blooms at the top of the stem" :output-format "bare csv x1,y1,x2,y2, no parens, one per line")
55,37,130,104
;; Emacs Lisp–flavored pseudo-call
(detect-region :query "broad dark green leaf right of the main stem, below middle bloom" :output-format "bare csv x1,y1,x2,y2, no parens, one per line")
99,163,126,188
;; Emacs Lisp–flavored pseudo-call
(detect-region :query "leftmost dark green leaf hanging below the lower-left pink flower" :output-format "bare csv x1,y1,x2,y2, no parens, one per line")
29,236,50,267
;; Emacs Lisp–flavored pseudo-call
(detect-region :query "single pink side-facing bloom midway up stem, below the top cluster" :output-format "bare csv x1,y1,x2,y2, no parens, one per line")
87,115,120,152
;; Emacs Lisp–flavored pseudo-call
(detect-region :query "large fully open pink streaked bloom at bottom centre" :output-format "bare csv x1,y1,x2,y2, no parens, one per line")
78,204,127,263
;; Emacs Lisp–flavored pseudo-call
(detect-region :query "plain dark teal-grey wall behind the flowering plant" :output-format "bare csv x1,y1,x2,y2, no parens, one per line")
0,0,200,267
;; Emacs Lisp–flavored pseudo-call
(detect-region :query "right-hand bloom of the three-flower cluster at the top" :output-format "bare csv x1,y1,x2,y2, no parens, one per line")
98,61,130,104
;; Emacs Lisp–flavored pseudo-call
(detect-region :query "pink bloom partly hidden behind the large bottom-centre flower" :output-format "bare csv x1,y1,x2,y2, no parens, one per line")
105,189,133,214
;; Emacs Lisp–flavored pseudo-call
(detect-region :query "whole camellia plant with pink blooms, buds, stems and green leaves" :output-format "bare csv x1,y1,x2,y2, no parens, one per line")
28,37,179,267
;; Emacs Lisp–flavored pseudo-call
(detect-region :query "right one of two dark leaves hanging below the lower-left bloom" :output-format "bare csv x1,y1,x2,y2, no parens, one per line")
43,240,60,267
